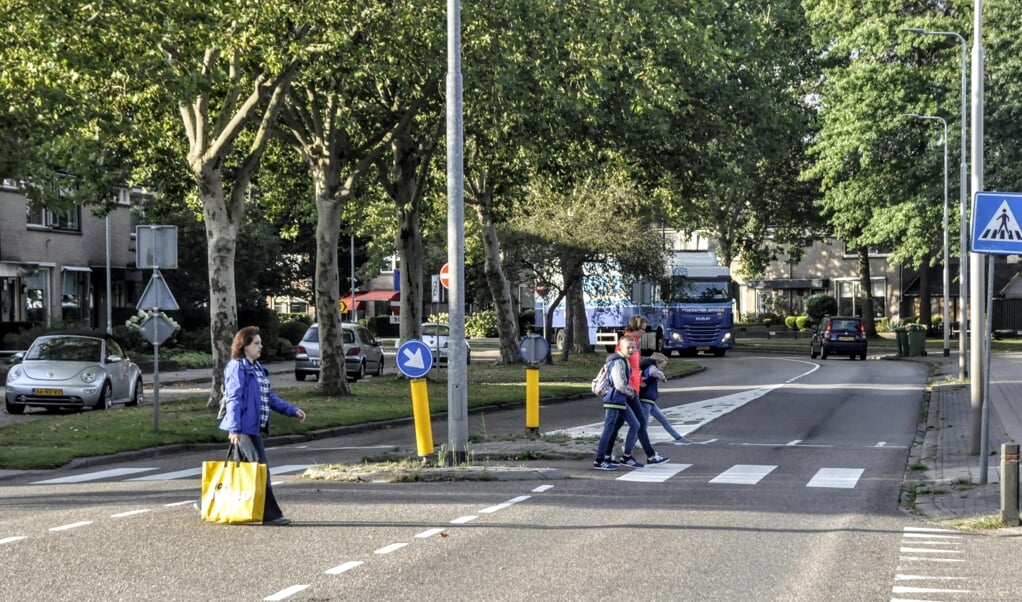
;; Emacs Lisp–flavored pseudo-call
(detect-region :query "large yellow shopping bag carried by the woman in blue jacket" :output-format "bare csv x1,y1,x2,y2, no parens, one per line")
201,446,267,523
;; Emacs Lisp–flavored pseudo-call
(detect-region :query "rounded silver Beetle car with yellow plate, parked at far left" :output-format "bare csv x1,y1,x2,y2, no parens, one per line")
4,334,144,414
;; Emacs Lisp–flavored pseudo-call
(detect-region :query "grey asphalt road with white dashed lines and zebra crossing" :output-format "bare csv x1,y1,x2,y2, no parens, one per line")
0,354,1022,601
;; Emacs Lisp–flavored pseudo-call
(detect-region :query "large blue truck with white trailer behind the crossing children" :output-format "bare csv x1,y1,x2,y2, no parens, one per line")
537,250,735,357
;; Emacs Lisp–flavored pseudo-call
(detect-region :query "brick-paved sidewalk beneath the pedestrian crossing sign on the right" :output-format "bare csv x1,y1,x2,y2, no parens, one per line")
904,353,1022,528
